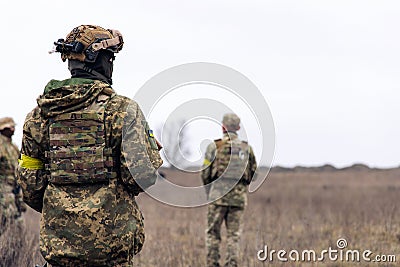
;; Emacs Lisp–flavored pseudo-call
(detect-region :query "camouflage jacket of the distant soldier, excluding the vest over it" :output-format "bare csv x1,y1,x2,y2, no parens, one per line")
201,132,257,208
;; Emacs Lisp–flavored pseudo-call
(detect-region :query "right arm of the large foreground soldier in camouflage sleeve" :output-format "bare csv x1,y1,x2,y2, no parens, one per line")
120,102,162,195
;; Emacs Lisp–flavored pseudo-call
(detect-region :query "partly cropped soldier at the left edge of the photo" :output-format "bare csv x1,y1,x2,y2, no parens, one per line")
0,117,26,234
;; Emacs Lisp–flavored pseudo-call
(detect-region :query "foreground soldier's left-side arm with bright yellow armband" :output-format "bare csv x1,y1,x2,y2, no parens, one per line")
16,110,48,212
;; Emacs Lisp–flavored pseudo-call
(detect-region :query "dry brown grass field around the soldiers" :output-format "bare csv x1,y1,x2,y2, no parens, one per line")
0,166,400,267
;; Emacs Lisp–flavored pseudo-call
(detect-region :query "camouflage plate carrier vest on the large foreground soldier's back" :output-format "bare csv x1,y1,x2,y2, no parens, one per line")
45,98,116,184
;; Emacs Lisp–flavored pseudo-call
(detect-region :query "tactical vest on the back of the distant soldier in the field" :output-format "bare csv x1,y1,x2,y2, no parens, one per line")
211,139,250,182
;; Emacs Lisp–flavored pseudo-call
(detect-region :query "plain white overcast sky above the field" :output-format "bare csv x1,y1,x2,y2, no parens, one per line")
0,0,400,167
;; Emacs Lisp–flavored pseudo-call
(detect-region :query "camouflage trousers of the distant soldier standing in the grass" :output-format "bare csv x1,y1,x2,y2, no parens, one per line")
206,204,244,267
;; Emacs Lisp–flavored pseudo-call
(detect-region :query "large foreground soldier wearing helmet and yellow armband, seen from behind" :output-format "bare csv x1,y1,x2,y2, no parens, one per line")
18,25,162,266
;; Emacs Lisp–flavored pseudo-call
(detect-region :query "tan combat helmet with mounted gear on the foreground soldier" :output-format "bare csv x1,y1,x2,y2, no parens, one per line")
51,25,124,63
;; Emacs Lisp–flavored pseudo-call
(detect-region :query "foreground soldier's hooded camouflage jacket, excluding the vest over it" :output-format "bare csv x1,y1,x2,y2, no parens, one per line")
17,78,162,266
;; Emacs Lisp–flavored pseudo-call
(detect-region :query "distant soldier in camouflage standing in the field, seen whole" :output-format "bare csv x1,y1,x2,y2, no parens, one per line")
201,113,257,266
